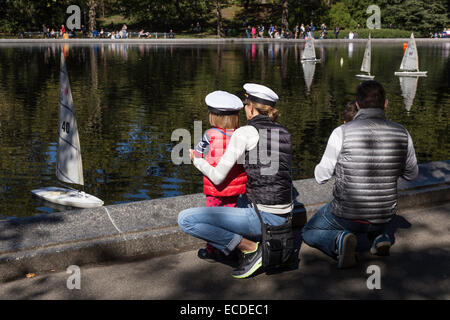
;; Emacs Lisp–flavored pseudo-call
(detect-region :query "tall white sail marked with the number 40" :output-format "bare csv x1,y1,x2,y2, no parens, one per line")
56,52,84,185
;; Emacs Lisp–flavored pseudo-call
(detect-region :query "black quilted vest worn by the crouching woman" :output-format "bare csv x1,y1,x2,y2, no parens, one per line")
244,115,292,205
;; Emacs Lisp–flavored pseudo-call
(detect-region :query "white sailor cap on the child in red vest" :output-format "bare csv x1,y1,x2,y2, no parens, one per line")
205,90,244,115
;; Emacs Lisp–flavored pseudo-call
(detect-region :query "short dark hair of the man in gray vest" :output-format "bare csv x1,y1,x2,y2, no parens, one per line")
356,80,386,109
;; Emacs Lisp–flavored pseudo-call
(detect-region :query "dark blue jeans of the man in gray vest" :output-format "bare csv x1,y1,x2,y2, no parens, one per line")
302,203,389,259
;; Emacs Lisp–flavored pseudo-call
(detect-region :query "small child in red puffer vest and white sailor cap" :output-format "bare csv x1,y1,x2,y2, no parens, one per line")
194,91,247,259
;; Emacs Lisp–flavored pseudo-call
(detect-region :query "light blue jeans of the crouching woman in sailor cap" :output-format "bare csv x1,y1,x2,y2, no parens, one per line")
178,205,286,255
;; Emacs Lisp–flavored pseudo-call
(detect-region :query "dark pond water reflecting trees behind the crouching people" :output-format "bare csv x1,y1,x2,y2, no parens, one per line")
0,41,450,218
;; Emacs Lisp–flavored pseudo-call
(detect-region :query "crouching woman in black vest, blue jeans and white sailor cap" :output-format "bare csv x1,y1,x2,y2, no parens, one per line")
178,84,292,278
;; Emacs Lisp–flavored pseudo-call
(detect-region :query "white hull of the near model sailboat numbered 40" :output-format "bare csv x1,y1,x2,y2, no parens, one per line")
31,187,103,208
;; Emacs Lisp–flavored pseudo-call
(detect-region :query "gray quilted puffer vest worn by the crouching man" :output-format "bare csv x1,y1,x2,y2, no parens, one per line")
331,108,408,223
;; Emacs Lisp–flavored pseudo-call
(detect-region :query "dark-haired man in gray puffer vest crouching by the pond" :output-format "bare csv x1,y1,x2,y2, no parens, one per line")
302,81,418,268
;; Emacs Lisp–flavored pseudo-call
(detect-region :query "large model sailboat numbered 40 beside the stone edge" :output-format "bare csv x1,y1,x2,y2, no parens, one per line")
31,52,103,208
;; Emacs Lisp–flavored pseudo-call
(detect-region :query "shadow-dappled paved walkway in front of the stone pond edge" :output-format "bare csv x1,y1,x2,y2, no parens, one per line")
0,203,450,300
